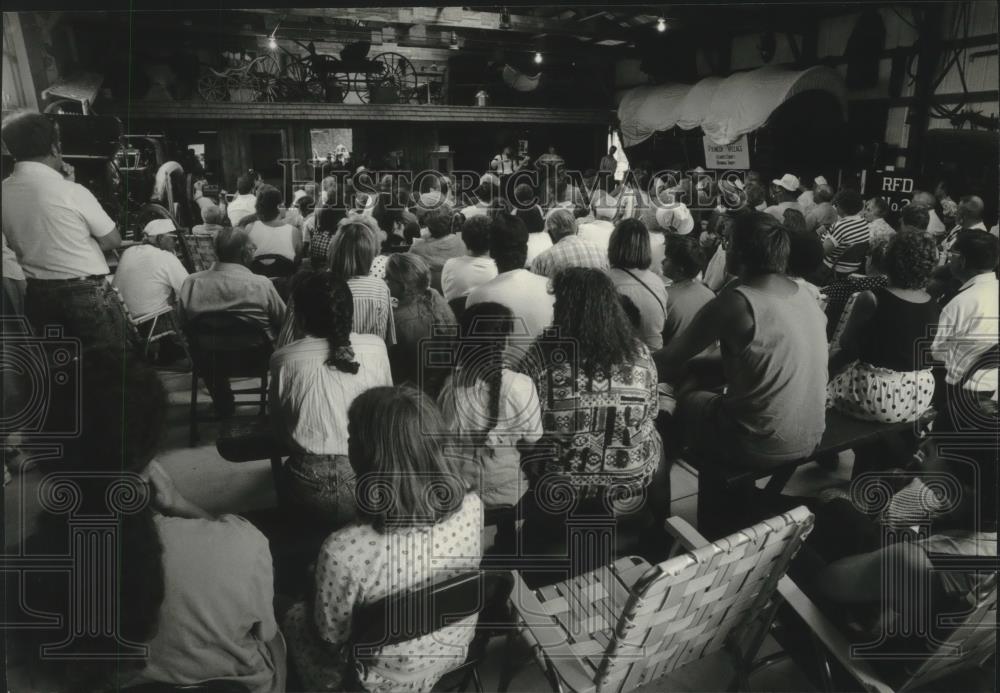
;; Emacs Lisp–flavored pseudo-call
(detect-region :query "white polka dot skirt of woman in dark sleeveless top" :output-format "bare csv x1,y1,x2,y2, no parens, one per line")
827,361,934,423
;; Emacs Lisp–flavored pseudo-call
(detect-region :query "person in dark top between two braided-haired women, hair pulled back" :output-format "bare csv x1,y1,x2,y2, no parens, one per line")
385,253,455,396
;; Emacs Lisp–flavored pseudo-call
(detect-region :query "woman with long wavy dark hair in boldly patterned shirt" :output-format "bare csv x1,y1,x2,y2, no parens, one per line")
525,267,661,498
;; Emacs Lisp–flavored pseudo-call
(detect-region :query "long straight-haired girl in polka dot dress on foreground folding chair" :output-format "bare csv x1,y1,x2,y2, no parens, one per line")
283,387,483,691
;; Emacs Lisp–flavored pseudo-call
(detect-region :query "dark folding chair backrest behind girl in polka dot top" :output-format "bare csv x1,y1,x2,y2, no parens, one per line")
351,570,512,659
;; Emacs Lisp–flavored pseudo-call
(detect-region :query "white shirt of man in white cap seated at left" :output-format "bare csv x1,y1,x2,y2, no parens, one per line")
113,243,188,318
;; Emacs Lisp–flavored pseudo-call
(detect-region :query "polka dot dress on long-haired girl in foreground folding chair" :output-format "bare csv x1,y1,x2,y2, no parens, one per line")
284,494,483,693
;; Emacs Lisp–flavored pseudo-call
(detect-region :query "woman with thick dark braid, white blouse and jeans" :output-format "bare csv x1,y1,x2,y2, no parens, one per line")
270,272,392,527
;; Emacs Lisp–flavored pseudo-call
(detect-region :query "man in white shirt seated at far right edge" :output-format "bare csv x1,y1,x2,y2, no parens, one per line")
931,230,1000,433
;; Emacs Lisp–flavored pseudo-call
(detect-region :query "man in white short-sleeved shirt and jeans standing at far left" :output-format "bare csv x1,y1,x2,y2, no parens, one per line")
2,112,130,348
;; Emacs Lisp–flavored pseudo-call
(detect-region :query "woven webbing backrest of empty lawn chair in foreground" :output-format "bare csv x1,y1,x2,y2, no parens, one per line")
597,506,813,690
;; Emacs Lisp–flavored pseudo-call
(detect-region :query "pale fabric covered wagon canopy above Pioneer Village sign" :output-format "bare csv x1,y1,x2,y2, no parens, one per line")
618,66,847,147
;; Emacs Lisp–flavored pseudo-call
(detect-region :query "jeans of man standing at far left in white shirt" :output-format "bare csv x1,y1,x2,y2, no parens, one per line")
24,277,137,352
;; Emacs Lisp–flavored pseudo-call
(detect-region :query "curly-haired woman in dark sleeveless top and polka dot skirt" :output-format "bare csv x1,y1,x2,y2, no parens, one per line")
828,231,940,423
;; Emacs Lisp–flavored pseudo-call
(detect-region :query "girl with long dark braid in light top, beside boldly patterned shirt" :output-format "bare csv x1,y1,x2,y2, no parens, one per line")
438,303,542,507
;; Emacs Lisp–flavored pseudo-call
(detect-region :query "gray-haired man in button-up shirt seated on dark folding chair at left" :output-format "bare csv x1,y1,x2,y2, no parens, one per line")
180,227,285,418
